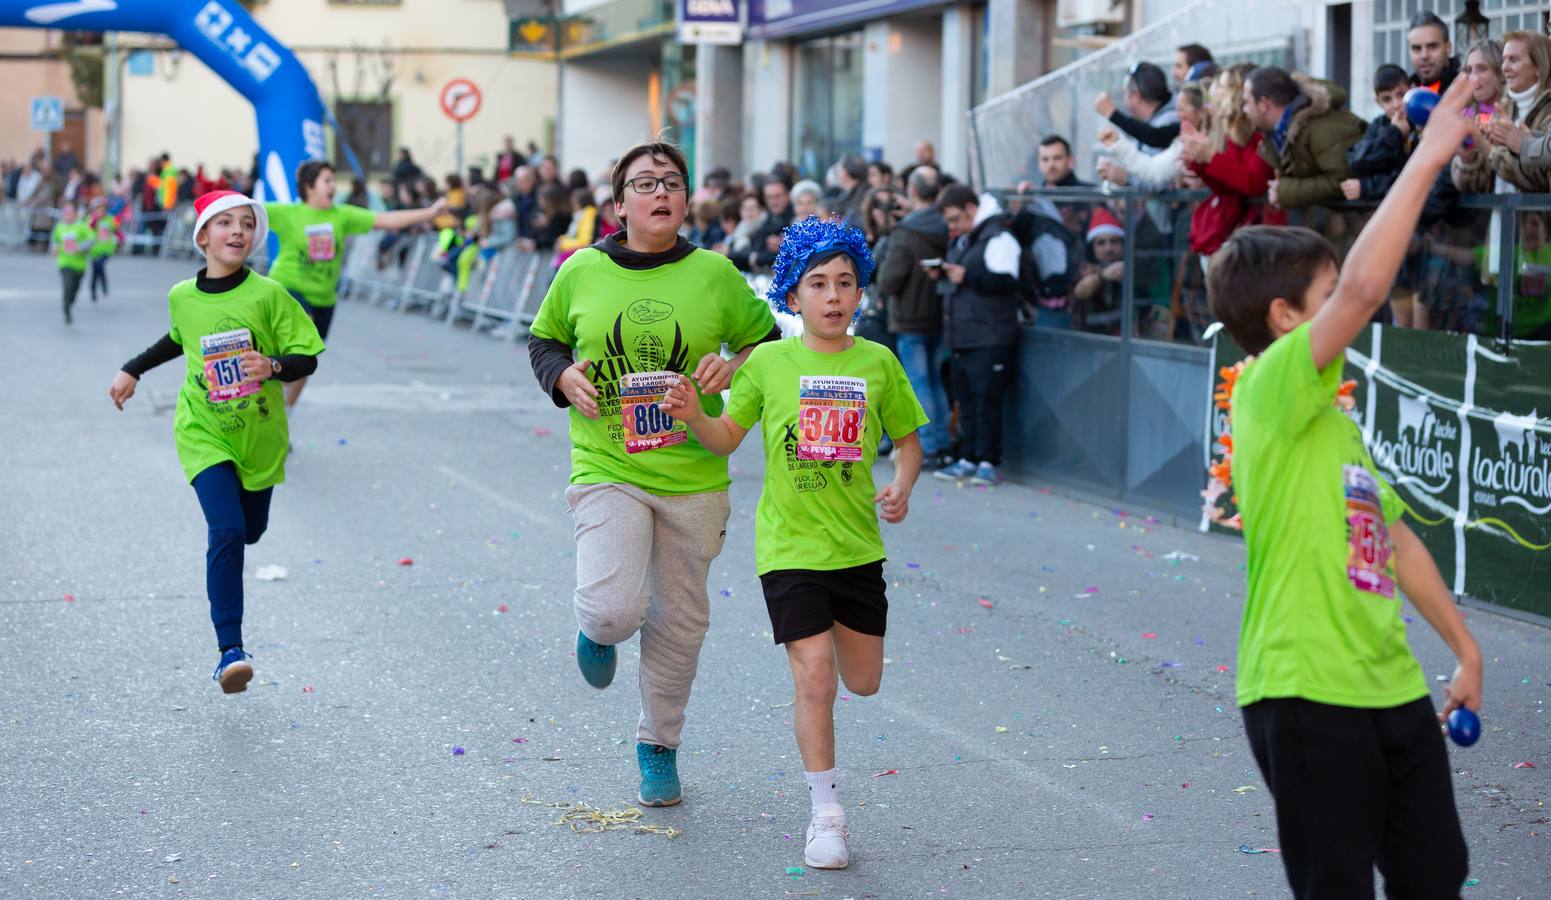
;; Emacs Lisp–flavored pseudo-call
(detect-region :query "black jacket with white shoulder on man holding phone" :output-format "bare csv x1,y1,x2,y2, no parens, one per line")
943,194,1022,351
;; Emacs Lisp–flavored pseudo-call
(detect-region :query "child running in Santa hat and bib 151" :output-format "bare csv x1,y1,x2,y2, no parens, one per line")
109,191,323,694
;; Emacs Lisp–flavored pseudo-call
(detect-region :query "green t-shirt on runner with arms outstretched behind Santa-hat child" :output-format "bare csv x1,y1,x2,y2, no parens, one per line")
264,203,377,306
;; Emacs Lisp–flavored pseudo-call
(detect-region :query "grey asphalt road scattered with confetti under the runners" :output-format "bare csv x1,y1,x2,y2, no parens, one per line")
0,256,1551,898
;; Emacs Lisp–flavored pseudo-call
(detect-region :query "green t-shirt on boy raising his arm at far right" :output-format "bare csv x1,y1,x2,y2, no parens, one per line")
1231,323,1427,709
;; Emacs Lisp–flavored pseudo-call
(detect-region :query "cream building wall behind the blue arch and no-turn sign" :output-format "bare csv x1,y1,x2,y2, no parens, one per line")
124,0,555,177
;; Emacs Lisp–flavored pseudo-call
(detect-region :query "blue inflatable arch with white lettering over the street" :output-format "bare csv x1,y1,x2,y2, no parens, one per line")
0,0,327,203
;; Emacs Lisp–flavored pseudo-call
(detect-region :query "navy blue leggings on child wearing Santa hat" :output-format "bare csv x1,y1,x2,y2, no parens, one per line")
194,462,275,647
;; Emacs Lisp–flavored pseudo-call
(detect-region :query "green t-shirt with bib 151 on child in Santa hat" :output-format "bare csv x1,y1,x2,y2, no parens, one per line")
168,272,323,490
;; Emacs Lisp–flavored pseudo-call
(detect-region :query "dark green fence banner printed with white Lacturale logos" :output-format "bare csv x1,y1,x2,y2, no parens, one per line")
1202,326,1551,616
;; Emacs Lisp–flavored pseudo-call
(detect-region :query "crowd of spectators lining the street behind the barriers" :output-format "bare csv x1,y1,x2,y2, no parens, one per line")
0,11,1551,481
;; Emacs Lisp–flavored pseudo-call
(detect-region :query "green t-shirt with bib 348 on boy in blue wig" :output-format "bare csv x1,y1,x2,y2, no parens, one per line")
727,337,927,574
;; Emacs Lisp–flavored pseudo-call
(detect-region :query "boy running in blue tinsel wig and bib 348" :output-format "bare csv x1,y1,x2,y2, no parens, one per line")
662,217,926,869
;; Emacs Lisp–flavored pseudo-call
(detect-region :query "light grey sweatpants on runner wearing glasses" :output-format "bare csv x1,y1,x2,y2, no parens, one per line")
566,484,731,748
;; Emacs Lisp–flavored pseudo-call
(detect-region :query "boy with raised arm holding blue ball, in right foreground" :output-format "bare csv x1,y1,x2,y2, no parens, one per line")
1203,78,1481,898
